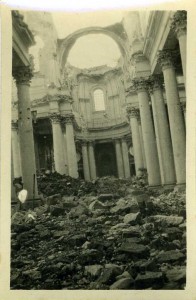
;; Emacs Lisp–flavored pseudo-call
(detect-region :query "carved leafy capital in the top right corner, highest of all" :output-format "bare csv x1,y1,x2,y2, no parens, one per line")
171,10,187,38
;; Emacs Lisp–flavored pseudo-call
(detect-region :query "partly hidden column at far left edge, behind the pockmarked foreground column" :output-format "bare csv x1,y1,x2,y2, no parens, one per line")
12,121,22,178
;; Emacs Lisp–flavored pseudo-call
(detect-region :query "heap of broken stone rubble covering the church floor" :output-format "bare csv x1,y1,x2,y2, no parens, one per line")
11,174,186,290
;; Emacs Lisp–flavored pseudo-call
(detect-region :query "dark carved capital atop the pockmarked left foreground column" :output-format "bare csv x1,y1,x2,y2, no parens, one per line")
12,66,33,85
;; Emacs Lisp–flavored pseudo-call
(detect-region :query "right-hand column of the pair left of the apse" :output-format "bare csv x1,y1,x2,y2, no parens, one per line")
64,114,78,178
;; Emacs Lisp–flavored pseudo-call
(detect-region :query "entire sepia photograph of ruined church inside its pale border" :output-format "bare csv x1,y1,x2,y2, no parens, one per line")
10,10,188,290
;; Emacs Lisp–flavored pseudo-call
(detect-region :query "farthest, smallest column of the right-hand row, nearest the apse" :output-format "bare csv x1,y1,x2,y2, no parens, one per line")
127,107,144,176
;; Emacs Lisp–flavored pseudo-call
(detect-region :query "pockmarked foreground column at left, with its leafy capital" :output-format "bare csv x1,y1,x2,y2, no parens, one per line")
13,66,38,200
